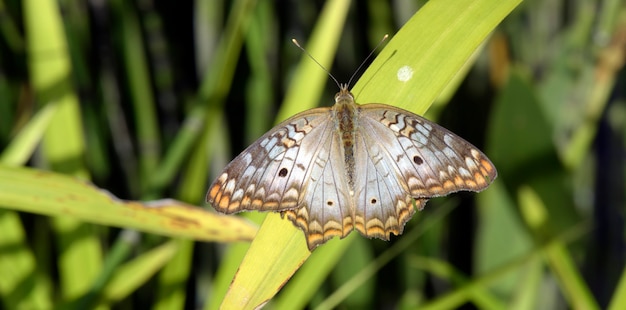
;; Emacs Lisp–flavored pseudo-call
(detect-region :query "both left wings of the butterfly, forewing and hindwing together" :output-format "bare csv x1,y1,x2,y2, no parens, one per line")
206,108,353,250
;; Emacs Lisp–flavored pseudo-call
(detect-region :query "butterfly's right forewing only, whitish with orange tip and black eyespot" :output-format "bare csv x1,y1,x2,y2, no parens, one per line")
361,104,497,198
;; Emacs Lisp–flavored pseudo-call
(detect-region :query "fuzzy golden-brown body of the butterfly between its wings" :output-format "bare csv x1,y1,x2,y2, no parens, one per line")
333,85,359,194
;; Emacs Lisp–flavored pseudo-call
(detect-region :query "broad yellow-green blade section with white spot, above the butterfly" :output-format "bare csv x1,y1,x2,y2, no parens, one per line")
353,0,521,114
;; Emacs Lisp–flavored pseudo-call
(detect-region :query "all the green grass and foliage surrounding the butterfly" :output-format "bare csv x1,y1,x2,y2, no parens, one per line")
0,0,626,309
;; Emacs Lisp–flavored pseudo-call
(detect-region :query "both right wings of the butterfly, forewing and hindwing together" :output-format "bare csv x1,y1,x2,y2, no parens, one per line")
355,104,497,240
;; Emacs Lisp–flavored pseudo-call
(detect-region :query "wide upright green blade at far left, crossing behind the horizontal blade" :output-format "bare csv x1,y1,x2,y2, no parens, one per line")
24,0,102,299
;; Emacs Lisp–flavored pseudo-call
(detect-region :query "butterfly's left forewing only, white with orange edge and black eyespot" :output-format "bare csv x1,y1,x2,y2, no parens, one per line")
206,108,332,213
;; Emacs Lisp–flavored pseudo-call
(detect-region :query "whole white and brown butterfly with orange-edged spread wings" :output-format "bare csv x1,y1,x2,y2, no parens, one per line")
206,84,497,251
